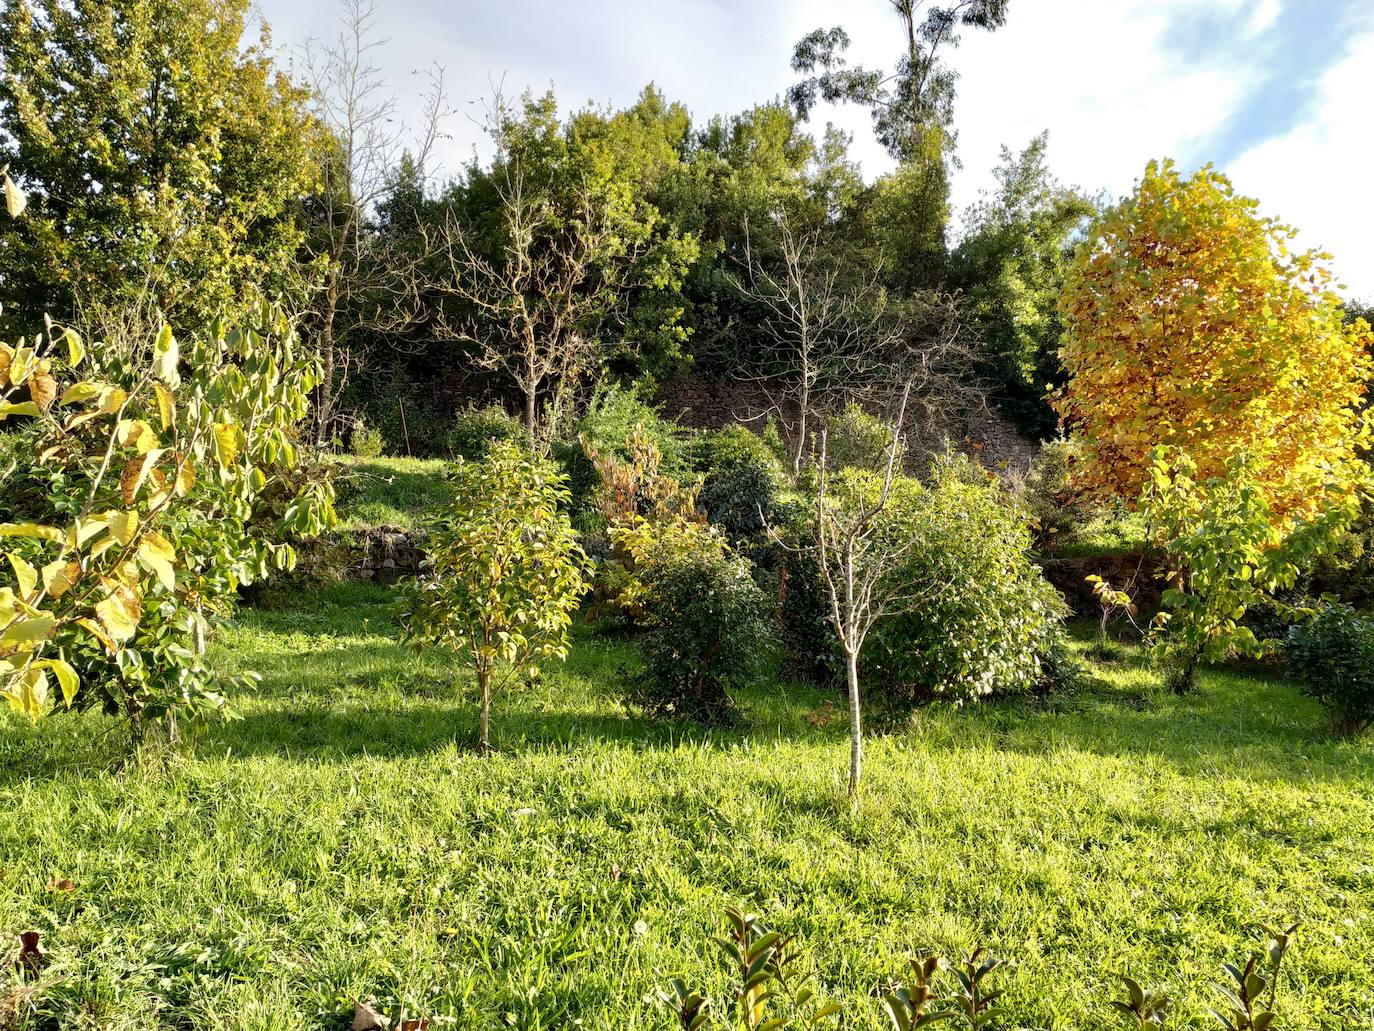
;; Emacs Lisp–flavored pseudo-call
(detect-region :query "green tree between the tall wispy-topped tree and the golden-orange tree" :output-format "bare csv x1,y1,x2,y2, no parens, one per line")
949,133,1095,439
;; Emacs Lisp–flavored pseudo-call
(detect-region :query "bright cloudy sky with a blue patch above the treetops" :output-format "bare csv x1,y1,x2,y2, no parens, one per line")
260,0,1374,298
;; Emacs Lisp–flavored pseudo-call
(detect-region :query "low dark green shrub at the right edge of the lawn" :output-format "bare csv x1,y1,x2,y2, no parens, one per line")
1285,603,1374,733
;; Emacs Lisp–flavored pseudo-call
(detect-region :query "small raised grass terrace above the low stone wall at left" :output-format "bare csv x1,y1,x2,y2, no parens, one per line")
334,455,449,531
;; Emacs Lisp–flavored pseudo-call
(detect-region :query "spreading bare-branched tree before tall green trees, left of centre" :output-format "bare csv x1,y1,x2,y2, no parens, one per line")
436,109,647,450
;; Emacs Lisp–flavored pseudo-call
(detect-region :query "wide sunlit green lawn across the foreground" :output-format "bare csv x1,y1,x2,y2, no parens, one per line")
0,586,1374,1031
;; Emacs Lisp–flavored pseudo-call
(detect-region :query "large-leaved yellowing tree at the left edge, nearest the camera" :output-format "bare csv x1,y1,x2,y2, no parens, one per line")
0,177,333,741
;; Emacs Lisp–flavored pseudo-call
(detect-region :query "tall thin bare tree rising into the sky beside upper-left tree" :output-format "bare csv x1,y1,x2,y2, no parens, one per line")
305,0,448,443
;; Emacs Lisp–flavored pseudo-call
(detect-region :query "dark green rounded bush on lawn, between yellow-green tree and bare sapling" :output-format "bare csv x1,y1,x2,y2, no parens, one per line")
633,531,771,722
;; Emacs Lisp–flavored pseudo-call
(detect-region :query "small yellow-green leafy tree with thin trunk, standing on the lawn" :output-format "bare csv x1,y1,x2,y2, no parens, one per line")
403,441,587,751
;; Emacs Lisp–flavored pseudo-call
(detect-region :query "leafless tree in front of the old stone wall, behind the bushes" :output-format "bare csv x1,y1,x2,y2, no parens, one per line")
735,210,901,473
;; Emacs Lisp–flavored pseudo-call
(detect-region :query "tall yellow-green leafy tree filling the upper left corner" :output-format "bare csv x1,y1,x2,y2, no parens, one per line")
0,0,317,331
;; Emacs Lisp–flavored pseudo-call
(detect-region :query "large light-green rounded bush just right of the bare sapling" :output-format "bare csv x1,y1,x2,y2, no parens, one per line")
864,456,1066,702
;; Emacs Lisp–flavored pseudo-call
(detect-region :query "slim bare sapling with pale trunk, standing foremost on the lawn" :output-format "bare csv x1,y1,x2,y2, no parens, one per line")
796,294,981,807
